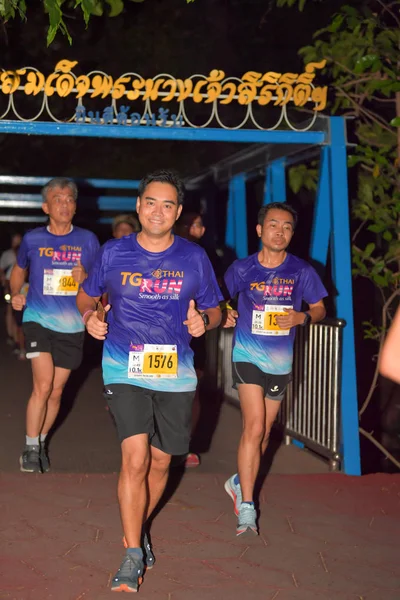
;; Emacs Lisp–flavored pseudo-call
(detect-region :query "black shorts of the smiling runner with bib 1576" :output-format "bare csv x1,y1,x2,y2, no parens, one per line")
104,383,195,455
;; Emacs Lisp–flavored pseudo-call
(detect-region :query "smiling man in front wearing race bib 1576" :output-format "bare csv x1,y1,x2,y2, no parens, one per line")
77,171,221,592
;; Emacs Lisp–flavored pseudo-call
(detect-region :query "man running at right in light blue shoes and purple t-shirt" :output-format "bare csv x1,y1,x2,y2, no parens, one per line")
222,202,327,535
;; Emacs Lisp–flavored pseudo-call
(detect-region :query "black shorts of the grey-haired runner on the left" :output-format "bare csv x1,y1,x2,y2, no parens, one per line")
22,321,85,370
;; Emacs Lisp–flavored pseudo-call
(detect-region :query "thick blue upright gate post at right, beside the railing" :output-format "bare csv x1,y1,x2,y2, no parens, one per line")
329,117,361,475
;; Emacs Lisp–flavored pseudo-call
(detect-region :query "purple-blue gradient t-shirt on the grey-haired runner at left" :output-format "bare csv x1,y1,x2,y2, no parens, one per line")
17,227,100,333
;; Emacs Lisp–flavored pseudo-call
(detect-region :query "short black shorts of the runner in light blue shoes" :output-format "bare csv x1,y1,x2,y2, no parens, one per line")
232,362,292,401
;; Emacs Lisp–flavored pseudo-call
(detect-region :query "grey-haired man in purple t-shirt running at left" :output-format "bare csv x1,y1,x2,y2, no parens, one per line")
10,178,100,473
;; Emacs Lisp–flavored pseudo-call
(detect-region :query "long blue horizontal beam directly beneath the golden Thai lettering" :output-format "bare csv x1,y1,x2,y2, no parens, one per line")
0,120,327,144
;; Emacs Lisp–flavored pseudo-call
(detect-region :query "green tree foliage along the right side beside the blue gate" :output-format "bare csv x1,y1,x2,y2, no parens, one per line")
277,0,400,466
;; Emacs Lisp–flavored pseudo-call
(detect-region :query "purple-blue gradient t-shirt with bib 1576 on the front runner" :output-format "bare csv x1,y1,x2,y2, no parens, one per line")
83,234,222,392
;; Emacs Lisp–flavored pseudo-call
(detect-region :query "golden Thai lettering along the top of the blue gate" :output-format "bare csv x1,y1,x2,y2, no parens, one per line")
0,60,327,111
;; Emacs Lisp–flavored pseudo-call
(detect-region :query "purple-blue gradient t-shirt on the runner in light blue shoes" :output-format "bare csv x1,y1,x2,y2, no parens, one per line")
225,253,328,375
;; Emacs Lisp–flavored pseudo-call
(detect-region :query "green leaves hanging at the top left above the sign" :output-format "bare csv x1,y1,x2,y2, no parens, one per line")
0,0,194,45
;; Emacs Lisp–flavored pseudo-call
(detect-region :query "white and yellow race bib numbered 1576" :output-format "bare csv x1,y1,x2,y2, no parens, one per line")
128,344,178,379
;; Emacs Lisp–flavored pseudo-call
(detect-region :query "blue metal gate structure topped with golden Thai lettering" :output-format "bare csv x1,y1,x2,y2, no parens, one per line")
0,61,361,475
